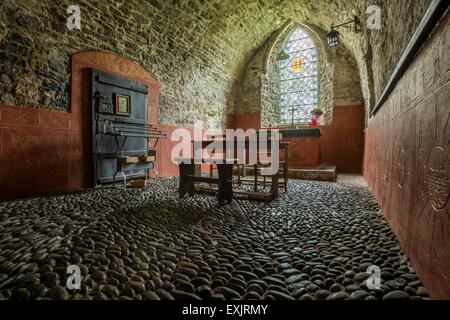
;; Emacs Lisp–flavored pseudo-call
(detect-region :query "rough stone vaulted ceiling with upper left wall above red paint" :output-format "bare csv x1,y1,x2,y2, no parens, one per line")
0,0,431,127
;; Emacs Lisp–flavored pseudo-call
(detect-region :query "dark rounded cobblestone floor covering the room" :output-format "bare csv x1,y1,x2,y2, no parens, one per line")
0,179,428,300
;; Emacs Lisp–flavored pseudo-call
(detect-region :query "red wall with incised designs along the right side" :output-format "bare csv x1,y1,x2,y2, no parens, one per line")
364,14,450,299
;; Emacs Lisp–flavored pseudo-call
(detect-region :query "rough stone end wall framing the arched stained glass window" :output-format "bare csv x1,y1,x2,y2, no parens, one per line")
248,24,364,127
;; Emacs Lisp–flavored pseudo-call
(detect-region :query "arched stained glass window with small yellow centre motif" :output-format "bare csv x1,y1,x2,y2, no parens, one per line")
279,28,319,124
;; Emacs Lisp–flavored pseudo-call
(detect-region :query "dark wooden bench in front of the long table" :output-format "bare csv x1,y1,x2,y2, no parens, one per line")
175,158,238,206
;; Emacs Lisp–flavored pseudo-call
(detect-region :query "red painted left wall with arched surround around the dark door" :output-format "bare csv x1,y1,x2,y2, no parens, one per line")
0,51,206,198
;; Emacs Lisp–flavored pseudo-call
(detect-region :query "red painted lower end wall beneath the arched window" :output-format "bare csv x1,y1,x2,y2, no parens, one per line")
229,105,364,173
